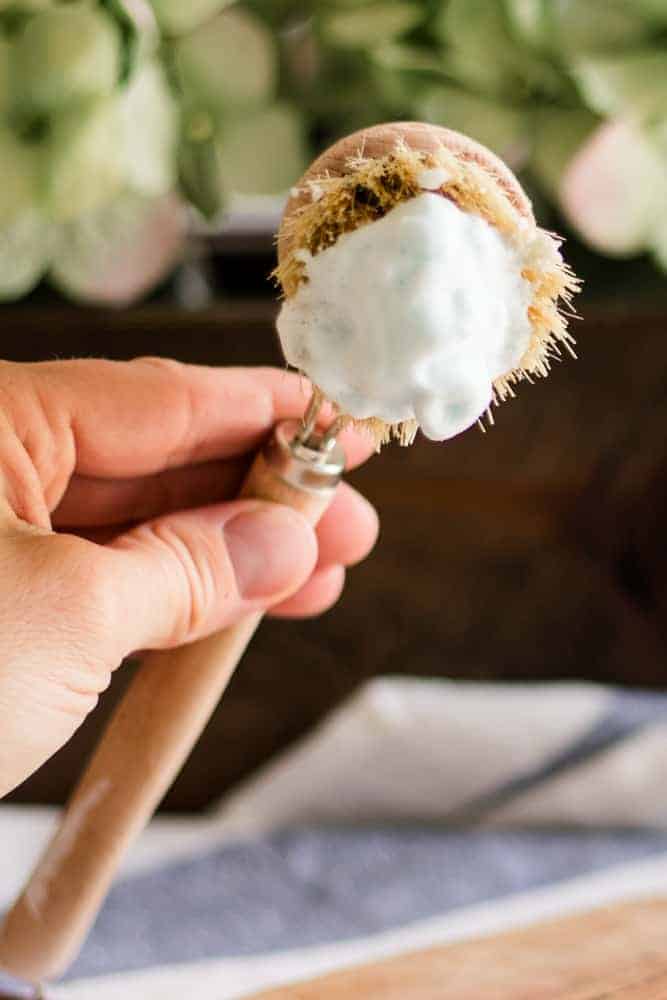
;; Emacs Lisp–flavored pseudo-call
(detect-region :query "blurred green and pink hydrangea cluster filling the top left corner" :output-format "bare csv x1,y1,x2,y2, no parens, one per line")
0,0,186,302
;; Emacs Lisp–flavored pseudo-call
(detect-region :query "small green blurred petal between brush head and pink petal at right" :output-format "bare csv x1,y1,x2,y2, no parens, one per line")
530,108,600,198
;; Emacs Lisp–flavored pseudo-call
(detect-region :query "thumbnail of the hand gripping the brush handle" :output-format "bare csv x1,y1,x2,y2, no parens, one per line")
223,504,317,600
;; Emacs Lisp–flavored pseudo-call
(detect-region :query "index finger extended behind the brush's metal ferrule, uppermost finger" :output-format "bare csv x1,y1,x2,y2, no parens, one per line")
27,358,373,478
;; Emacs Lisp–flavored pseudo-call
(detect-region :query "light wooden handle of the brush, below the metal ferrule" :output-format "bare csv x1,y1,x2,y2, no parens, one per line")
0,428,344,981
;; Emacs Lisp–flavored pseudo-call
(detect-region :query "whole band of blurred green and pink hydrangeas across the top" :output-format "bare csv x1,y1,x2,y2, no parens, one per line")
0,0,667,302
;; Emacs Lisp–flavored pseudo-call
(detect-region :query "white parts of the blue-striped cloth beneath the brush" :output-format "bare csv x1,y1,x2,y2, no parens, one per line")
0,678,667,1000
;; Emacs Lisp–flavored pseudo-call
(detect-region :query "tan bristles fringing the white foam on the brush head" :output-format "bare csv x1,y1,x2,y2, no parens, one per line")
274,141,579,447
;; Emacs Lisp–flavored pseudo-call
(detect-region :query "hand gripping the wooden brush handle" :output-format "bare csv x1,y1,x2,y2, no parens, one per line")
0,359,377,795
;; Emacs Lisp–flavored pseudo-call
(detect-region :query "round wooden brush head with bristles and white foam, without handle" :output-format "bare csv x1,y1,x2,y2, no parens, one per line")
275,122,577,445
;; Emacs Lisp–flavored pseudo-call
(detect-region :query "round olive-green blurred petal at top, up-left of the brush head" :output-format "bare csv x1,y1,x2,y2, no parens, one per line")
173,7,277,114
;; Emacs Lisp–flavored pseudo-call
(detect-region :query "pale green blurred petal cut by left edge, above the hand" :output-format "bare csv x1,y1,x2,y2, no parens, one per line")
0,212,51,301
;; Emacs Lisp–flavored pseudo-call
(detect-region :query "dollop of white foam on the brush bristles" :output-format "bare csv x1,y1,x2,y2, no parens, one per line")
278,193,532,441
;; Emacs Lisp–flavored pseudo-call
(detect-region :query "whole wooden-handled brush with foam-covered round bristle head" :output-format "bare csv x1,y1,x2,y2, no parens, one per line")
0,123,576,979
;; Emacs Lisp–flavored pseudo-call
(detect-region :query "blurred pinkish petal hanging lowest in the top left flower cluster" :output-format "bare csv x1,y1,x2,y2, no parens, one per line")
49,192,186,306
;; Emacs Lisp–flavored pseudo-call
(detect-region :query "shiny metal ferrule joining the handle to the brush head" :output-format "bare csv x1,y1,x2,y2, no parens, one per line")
264,420,345,493
